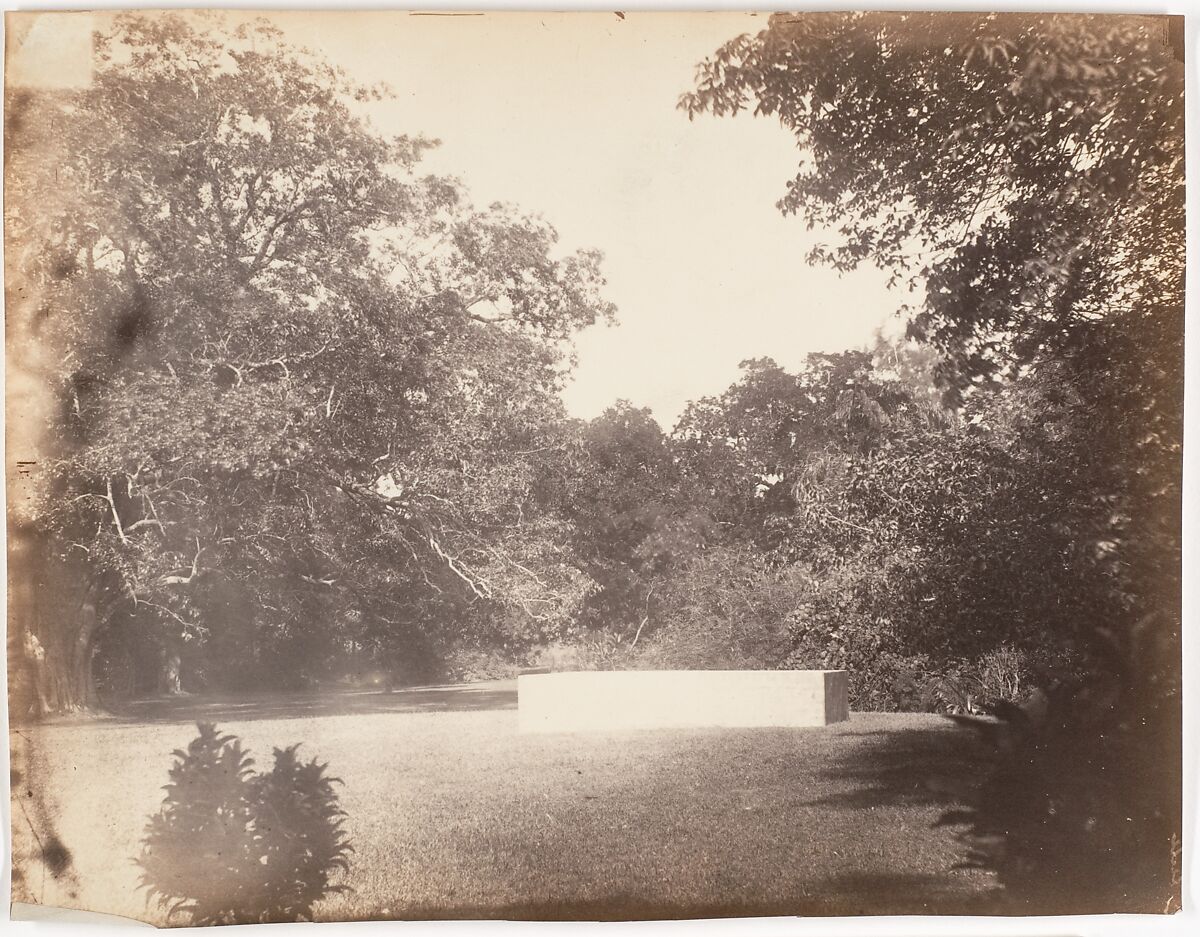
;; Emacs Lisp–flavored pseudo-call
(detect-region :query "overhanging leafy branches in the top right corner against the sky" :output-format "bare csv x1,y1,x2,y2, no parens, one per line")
683,13,1184,389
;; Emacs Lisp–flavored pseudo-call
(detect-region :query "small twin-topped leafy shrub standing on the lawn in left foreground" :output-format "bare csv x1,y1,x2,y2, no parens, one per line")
137,723,352,926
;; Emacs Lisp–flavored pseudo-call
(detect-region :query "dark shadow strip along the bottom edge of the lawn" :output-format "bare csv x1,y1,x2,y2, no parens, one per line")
350,872,996,921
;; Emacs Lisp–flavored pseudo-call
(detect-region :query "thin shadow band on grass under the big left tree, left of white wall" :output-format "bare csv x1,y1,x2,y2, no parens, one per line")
71,681,517,725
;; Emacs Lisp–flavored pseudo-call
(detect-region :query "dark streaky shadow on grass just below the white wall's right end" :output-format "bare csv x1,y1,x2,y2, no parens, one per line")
811,720,988,810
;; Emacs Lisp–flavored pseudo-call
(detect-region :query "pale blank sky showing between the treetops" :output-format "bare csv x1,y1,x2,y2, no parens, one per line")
9,12,907,428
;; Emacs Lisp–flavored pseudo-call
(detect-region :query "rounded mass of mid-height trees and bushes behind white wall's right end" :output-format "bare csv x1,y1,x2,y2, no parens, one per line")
659,344,1080,710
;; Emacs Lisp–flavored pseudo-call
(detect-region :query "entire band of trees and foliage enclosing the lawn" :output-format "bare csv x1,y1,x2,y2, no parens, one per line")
5,7,1184,911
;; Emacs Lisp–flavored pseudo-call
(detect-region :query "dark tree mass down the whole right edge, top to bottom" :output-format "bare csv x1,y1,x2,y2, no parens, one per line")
682,13,1184,911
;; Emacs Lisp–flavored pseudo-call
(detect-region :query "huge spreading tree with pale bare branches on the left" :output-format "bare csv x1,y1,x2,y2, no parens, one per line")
6,14,611,708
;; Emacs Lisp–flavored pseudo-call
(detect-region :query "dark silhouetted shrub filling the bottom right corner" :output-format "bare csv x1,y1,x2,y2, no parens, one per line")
944,609,1182,914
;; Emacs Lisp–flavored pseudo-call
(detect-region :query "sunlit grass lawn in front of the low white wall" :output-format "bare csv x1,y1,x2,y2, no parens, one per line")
12,684,994,924
